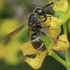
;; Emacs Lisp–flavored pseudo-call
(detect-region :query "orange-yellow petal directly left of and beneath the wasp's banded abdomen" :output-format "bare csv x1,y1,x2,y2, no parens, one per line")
21,42,41,55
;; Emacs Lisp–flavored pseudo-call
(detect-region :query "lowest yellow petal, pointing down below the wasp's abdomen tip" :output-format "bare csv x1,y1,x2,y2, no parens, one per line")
25,52,46,69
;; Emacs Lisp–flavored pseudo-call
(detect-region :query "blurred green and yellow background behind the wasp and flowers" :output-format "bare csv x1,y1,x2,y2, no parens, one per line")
0,0,70,70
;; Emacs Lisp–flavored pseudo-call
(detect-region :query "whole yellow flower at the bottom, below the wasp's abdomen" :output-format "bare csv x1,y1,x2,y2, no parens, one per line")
21,42,47,69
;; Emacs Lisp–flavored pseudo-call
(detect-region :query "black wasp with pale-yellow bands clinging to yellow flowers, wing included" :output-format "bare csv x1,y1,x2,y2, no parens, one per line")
4,2,53,50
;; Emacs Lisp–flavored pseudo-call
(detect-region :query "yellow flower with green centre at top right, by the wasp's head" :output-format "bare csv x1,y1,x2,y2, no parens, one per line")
44,0,70,29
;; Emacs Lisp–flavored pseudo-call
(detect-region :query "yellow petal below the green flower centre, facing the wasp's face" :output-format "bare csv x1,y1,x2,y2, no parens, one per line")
44,15,68,29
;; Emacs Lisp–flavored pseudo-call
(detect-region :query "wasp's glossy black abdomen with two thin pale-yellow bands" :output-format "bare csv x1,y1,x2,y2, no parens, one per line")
30,33,47,51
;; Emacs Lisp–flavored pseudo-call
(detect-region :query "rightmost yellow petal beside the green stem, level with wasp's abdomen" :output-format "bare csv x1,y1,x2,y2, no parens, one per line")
53,34,69,50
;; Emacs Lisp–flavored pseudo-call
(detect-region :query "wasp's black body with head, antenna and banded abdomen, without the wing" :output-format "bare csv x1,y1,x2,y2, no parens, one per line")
28,2,53,51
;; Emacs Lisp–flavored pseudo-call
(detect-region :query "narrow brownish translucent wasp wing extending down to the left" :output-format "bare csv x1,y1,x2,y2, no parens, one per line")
3,24,27,43
